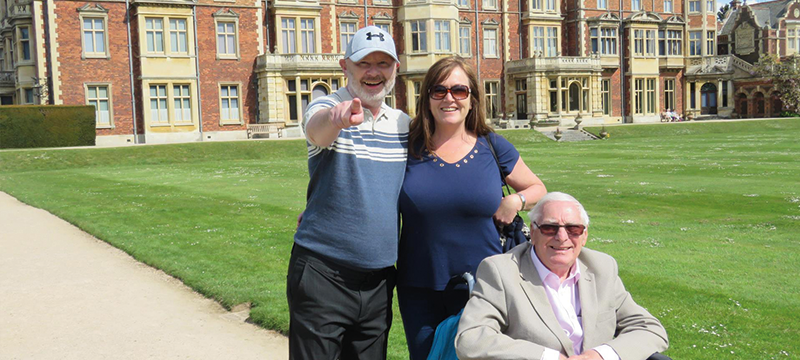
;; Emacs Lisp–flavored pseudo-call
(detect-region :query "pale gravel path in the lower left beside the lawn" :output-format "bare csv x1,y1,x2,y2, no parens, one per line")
0,192,288,360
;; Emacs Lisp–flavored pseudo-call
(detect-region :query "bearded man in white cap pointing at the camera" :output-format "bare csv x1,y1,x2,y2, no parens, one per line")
286,26,410,360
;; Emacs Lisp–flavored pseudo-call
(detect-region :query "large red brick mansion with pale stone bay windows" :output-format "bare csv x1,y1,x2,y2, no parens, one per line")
0,0,800,144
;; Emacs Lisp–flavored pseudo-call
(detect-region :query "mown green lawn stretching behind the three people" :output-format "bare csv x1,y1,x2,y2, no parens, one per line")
0,119,800,360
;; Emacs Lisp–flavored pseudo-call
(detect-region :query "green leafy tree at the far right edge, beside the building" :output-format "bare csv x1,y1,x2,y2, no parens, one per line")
751,54,800,113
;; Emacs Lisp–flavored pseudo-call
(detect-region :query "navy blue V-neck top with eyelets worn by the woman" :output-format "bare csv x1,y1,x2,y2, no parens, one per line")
397,133,519,290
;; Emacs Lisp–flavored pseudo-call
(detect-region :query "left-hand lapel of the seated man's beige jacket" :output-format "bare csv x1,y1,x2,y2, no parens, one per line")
517,243,575,356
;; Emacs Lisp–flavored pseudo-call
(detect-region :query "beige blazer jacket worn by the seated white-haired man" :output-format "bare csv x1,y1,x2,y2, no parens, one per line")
456,243,668,360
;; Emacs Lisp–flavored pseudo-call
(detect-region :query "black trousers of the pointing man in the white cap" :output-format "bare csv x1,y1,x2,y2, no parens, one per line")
286,245,395,360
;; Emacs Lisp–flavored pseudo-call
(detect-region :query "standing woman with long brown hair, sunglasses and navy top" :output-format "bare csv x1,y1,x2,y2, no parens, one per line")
397,57,547,359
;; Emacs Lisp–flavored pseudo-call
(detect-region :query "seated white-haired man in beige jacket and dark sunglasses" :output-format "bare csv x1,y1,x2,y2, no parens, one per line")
456,192,668,360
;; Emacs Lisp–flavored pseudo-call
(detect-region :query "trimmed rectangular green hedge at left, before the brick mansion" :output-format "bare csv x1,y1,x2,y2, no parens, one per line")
0,105,95,149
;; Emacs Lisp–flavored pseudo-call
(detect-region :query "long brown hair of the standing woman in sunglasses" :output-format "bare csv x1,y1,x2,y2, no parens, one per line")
408,56,493,159
